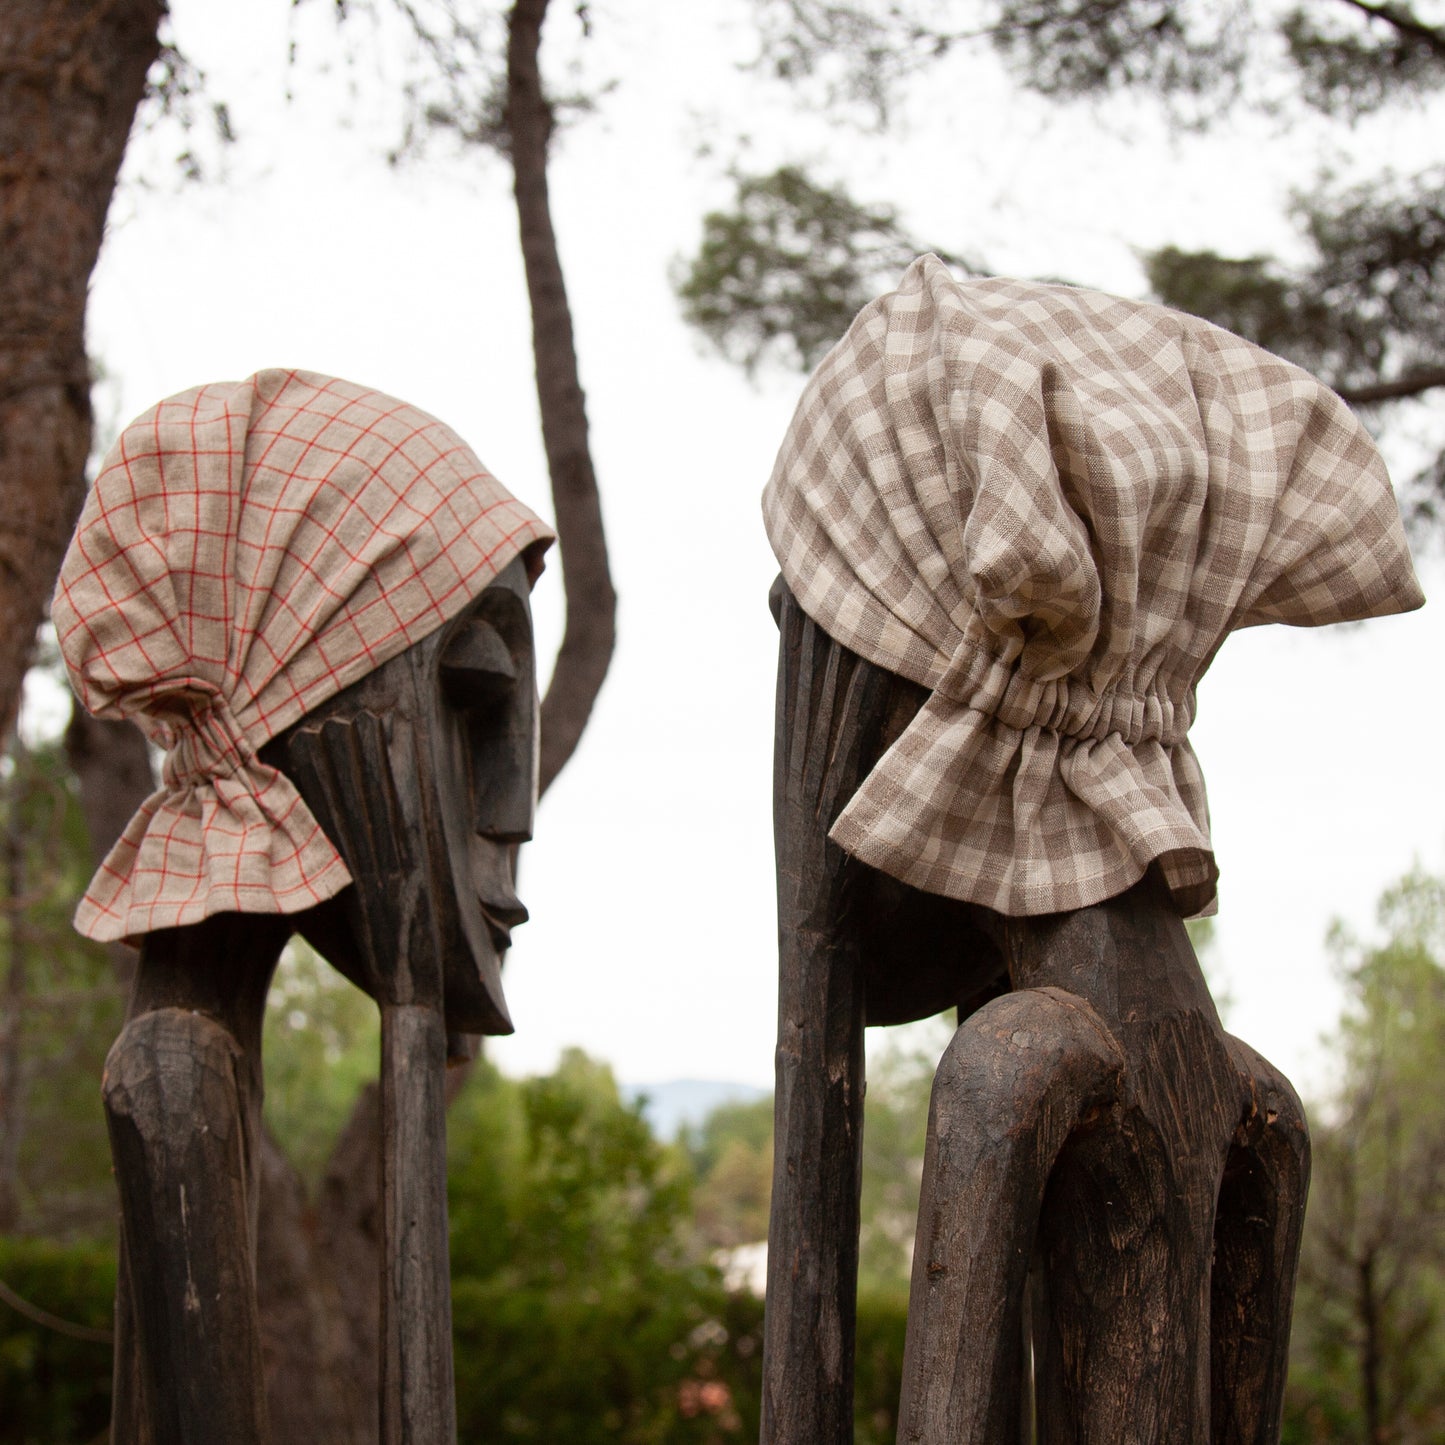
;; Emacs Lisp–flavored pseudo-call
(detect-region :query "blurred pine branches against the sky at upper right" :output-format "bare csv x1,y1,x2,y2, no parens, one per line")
678,0,1445,508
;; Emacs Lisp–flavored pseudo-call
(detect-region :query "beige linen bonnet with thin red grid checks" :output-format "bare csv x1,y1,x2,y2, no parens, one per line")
51,370,552,939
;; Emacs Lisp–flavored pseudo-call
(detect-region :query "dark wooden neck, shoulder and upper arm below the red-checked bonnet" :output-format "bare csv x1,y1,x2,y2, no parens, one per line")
103,915,290,1445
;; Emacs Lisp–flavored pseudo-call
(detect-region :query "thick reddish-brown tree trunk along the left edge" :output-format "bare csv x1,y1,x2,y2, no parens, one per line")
0,0,165,734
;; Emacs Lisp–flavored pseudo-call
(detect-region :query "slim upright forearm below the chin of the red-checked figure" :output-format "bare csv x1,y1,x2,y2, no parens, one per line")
381,1004,457,1445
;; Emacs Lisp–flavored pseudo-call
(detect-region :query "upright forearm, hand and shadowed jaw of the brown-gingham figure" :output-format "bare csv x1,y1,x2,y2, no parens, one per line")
763,590,1003,1445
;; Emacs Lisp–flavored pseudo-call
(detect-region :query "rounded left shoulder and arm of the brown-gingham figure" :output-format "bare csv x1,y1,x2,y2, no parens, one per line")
897,990,1124,1445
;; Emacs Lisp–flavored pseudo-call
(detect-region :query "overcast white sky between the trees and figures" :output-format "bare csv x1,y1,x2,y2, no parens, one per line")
70,0,1445,1091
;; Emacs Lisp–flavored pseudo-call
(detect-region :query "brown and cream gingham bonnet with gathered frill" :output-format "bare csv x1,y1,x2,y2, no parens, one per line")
763,256,1423,916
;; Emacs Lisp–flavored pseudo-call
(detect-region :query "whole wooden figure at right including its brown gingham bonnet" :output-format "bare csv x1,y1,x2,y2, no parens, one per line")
763,257,1422,1445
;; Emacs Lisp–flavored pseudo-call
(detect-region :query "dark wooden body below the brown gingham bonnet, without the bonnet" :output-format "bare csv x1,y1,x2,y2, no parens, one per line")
763,581,1309,1445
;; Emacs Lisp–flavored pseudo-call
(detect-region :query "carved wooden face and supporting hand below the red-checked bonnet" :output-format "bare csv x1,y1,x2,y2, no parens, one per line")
263,559,538,1033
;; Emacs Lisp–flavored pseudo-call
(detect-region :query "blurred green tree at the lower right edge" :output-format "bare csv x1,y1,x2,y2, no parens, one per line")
1289,871,1445,1445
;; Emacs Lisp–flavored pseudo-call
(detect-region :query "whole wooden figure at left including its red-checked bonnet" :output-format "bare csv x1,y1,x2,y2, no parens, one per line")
53,371,551,1445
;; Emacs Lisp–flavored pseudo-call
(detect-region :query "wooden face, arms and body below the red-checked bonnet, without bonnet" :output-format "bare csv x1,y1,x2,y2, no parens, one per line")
104,558,536,1445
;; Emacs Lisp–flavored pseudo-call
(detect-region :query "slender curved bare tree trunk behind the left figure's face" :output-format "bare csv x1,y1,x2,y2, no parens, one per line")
507,0,617,793
